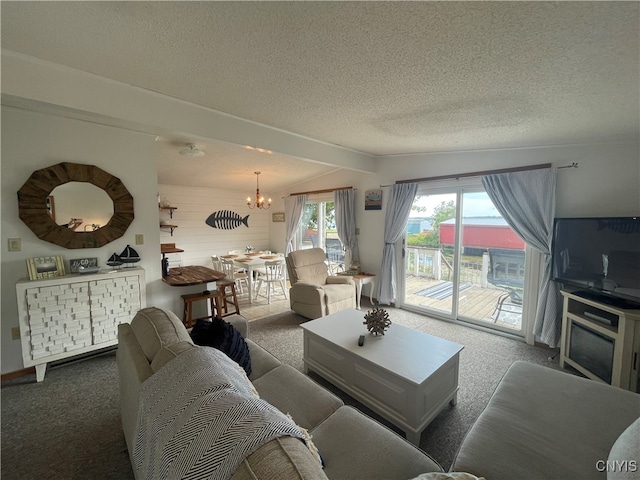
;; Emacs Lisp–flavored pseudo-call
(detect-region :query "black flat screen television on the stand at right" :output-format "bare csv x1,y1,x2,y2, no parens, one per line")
552,217,640,308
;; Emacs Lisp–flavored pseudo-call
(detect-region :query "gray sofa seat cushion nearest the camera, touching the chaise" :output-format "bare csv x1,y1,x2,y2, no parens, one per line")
311,406,442,480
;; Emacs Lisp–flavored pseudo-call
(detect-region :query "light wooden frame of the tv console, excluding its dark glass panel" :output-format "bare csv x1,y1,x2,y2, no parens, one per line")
560,290,640,392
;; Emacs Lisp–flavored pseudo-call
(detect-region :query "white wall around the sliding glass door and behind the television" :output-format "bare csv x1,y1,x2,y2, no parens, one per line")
271,142,640,296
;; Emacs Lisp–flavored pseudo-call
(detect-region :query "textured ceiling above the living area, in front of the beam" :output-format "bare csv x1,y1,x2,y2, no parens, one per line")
0,2,640,188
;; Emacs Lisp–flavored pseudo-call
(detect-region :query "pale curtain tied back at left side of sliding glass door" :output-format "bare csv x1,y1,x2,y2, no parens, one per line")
378,183,418,305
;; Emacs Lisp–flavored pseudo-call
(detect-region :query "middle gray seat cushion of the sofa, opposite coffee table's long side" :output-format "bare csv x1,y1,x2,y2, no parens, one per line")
253,364,344,430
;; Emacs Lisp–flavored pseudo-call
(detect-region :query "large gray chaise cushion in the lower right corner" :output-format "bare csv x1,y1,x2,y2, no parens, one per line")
451,362,640,480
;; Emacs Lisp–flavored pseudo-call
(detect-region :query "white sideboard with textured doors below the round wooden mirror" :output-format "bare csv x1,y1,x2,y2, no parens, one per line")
16,268,146,382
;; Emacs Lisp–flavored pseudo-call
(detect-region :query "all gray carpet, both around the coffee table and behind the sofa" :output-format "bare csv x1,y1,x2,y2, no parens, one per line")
0,308,558,479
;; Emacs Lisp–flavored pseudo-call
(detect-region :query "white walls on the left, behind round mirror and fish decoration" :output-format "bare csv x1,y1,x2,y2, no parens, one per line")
0,107,277,373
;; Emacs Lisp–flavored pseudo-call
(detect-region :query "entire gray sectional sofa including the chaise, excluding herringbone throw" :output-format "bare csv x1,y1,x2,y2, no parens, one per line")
117,307,640,480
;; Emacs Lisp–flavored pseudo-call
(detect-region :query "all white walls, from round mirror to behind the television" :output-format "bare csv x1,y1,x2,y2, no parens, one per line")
0,85,640,373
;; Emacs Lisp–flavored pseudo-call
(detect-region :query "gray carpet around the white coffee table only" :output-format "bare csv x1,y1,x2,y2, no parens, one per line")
249,307,560,470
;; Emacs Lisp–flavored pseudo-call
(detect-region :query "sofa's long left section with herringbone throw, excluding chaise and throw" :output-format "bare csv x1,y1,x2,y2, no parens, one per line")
116,307,442,480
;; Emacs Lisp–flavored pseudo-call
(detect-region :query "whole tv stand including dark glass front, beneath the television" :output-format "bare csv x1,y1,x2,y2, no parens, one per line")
560,290,640,392
